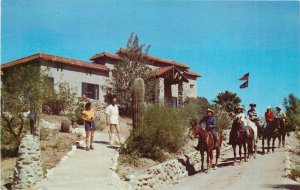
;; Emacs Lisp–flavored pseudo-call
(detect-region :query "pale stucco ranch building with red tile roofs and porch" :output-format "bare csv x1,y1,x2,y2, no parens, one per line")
1,50,201,106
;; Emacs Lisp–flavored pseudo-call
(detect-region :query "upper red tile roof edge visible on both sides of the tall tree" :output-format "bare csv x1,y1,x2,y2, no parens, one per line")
91,49,189,69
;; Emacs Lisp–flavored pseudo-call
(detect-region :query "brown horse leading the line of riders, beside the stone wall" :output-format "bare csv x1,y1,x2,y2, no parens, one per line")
189,120,222,171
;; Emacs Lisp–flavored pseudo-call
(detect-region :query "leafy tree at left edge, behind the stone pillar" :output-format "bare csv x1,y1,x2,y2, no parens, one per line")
1,65,53,150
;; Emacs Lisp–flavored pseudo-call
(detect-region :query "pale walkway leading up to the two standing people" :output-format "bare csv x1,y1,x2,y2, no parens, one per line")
41,132,126,190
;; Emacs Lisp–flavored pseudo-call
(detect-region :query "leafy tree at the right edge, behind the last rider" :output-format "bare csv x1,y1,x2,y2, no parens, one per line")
283,94,300,130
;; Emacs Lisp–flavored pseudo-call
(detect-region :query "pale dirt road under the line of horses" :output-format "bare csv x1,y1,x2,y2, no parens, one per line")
170,140,300,190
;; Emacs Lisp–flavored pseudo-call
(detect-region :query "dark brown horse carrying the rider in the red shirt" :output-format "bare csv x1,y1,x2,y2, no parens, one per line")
262,118,287,154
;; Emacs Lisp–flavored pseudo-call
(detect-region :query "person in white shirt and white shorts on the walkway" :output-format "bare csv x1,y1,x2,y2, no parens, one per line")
105,98,121,144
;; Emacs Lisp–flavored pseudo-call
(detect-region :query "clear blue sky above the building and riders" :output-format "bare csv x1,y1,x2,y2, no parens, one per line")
1,0,300,113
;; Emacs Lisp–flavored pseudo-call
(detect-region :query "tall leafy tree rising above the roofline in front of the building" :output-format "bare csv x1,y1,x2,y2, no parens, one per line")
108,34,155,113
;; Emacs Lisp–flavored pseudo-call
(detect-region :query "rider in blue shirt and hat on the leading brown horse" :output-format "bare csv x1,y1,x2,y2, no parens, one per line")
199,109,218,144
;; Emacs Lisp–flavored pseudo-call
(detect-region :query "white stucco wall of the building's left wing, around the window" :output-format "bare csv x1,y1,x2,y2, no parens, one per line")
41,63,108,102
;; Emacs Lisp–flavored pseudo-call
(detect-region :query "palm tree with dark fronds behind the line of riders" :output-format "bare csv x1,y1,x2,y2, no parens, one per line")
213,90,242,113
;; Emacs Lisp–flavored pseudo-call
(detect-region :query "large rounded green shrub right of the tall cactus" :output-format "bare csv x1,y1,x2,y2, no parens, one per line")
120,105,186,160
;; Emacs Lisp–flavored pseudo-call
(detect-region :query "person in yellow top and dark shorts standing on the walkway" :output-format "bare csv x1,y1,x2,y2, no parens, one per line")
82,102,95,151
